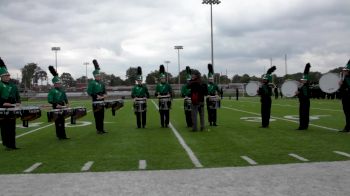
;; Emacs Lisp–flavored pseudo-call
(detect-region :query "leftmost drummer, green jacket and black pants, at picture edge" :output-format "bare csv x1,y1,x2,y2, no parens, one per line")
0,58,21,150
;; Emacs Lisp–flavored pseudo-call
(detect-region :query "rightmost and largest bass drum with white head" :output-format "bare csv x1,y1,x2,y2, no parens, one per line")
319,73,340,93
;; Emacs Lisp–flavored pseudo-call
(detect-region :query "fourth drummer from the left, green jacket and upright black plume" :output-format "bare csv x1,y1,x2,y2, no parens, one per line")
131,67,149,128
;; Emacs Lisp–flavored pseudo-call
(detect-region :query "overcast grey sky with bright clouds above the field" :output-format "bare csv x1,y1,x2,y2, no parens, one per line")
0,0,350,79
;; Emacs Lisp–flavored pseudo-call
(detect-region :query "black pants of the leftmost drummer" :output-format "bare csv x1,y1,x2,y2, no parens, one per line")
0,119,16,148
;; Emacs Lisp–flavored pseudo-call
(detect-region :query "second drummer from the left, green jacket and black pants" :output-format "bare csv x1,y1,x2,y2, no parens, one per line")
47,66,69,140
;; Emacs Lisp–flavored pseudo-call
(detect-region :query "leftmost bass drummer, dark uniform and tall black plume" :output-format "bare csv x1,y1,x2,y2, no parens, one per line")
258,66,276,128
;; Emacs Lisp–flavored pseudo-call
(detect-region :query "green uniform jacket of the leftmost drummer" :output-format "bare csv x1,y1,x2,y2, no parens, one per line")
0,81,21,107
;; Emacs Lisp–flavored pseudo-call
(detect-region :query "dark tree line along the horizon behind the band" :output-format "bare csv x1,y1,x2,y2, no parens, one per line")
17,63,342,89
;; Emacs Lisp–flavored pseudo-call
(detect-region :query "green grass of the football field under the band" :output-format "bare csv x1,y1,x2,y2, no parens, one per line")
0,98,350,174
